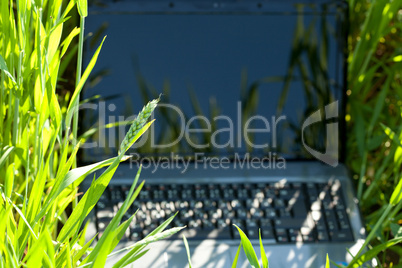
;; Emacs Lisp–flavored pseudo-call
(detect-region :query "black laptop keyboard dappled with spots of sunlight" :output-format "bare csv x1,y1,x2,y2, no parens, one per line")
95,181,353,243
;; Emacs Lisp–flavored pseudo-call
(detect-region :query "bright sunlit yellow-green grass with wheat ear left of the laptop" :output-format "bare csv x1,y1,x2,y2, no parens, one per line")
0,0,180,267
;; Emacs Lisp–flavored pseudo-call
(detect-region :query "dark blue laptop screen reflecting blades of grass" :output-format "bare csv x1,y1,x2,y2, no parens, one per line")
80,1,344,165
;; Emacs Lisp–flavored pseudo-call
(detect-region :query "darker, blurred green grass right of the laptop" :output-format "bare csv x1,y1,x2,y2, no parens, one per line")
346,0,402,267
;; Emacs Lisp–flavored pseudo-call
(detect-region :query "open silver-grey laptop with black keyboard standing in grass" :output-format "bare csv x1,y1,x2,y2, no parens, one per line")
80,0,364,267
